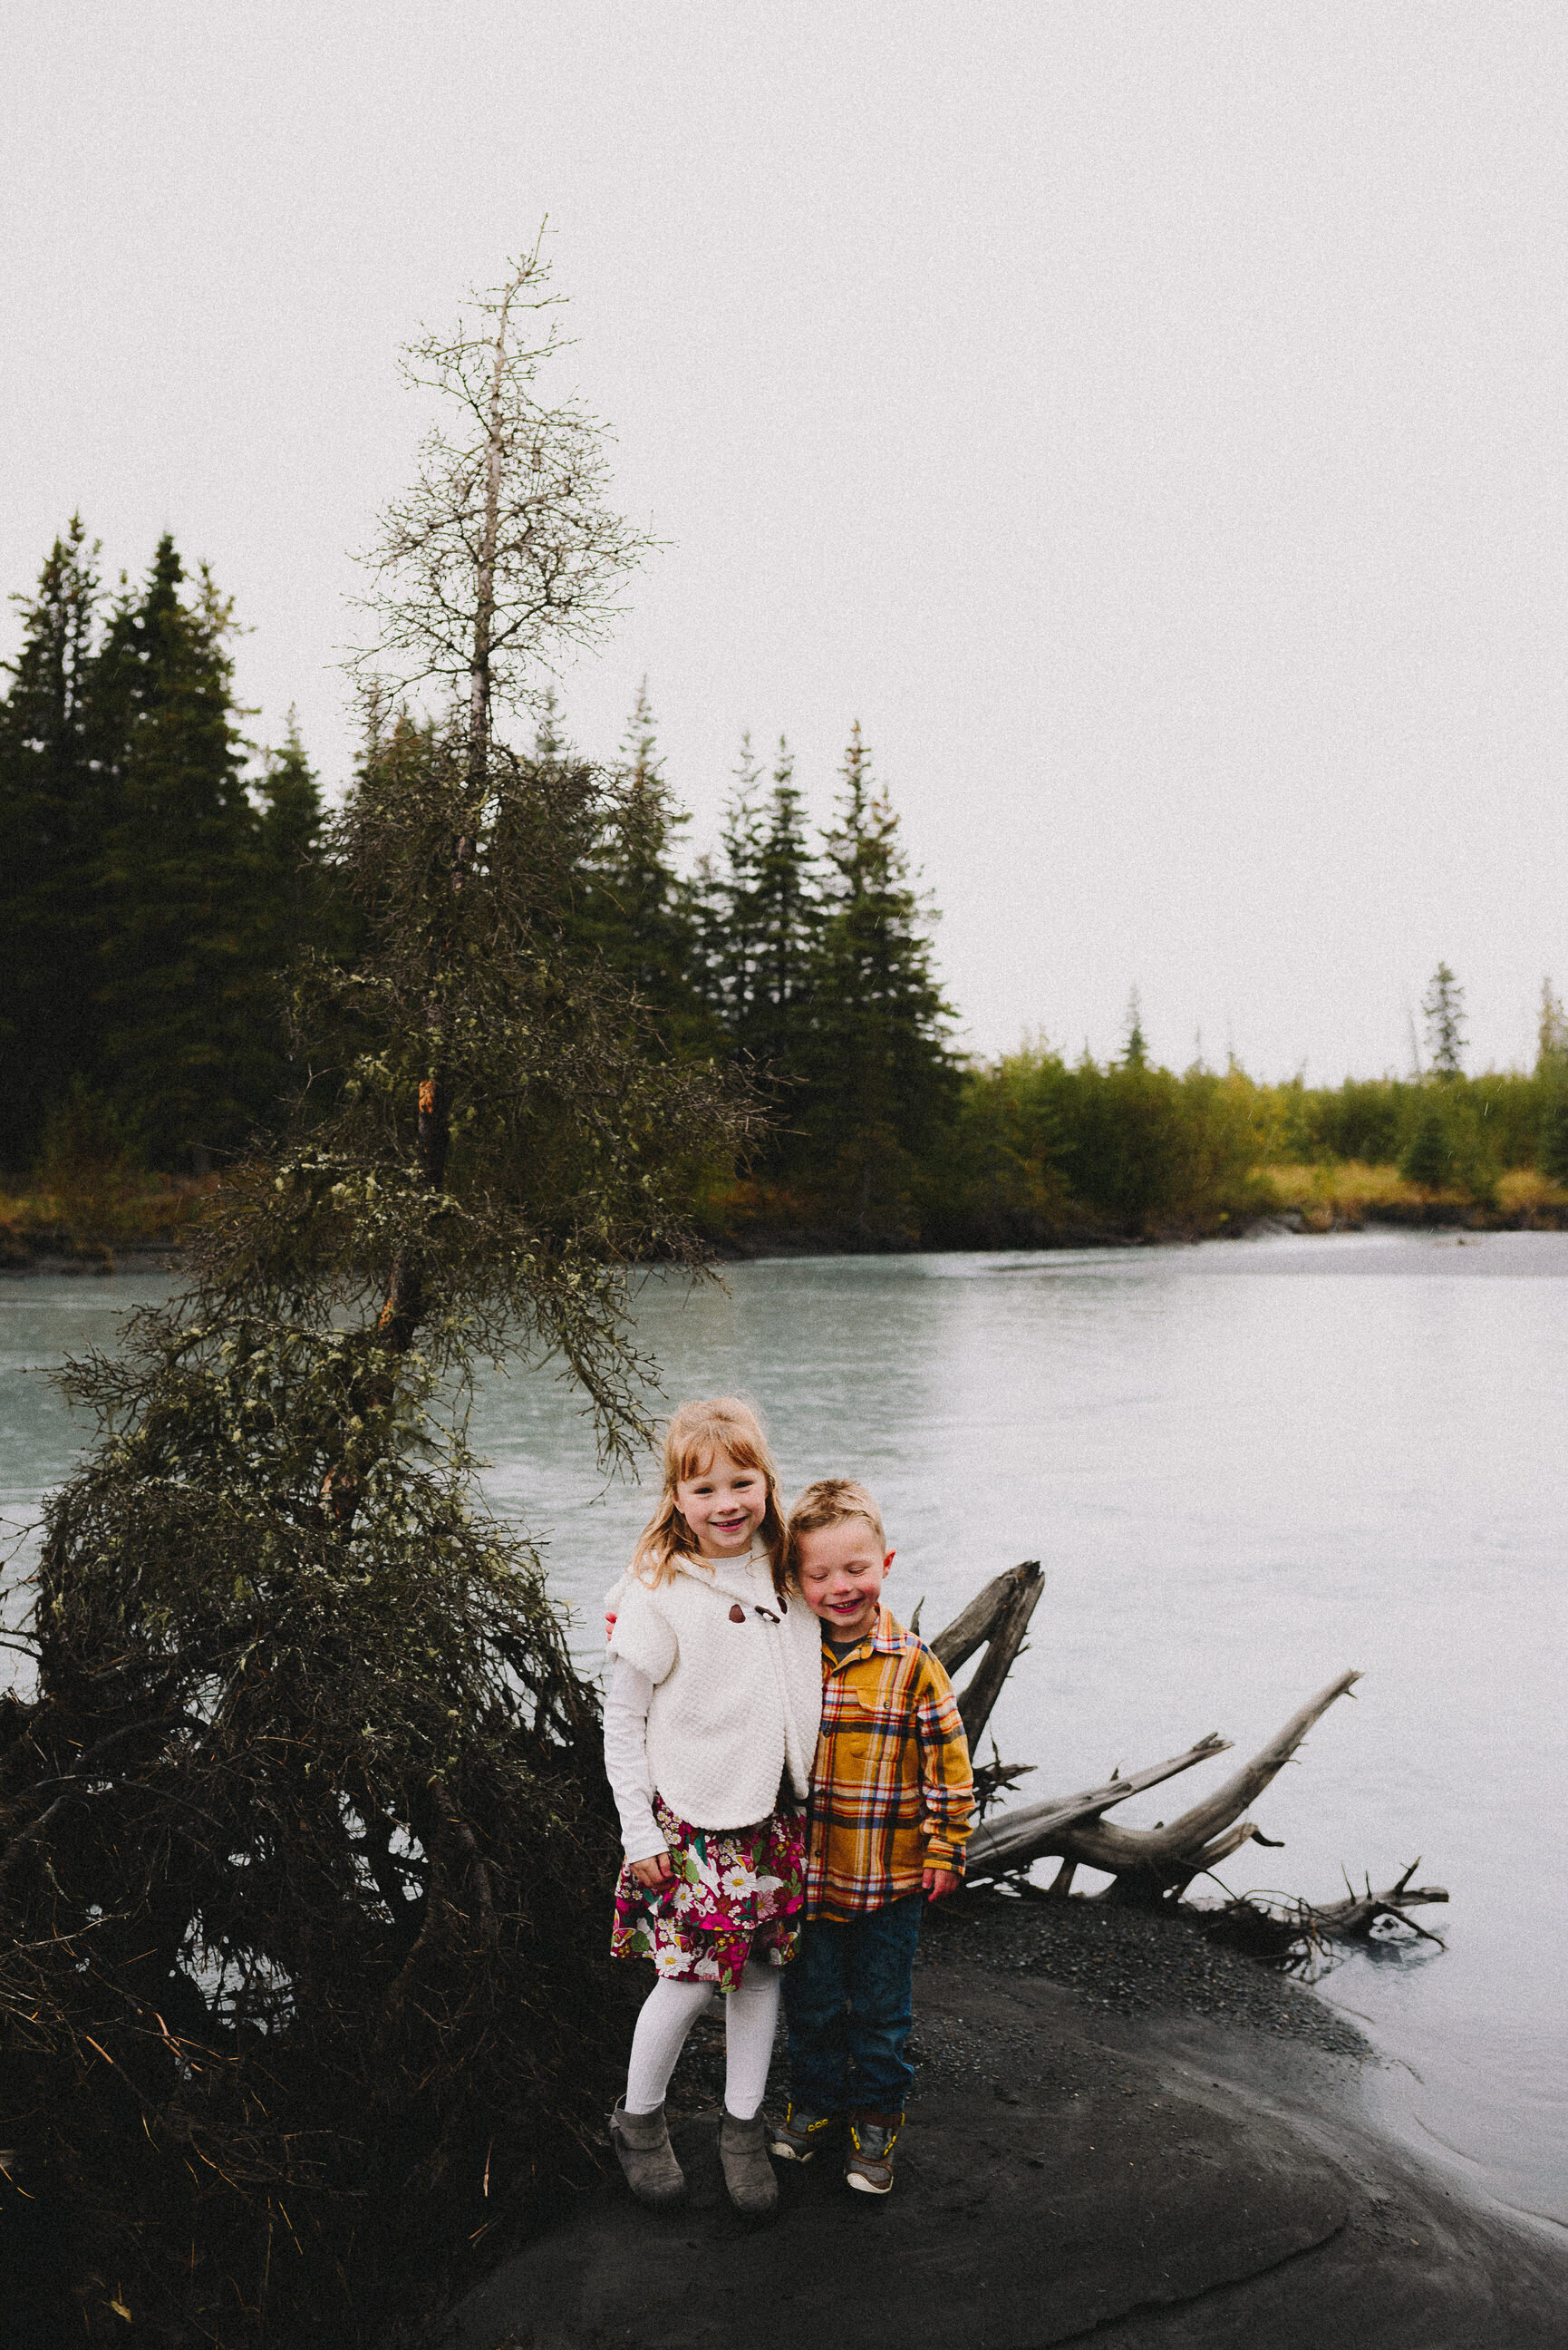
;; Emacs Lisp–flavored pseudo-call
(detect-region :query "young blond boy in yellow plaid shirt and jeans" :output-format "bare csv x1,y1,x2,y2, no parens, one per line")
771,1478,973,2195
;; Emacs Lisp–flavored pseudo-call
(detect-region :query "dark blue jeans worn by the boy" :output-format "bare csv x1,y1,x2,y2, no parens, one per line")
783,1894,924,2112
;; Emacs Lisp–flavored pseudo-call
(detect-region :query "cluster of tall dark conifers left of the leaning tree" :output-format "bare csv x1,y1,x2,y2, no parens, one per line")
0,521,334,1172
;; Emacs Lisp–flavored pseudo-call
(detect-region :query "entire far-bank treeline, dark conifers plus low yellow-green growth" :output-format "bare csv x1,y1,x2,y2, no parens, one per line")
0,521,1568,1248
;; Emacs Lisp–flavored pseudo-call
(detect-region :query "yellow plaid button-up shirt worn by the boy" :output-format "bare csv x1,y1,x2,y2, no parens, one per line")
807,1607,975,1918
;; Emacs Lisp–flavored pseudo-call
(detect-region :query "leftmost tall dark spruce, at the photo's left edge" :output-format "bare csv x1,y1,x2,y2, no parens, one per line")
0,515,108,1175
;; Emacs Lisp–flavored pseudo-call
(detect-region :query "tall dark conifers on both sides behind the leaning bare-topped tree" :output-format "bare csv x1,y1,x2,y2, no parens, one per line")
0,521,959,1243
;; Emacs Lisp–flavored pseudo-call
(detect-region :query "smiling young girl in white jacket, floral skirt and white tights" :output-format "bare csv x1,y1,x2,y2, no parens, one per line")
605,1396,823,2214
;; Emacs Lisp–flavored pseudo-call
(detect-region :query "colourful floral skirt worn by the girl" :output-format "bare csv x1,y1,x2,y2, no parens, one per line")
609,1795,807,1990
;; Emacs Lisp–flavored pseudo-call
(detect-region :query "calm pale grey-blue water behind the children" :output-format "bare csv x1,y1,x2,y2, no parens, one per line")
0,1234,1568,2226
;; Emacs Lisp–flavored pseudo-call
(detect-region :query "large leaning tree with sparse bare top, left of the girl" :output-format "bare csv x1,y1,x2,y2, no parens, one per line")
0,243,752,2350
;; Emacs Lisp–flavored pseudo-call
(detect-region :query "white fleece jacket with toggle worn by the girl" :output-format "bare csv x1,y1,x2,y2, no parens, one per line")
609,1553,823,1829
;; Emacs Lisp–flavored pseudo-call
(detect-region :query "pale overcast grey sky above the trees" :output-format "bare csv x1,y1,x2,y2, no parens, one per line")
0,0,1568,1081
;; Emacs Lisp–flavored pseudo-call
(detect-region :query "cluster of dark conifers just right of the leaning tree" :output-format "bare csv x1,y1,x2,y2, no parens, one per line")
586,695,962,1246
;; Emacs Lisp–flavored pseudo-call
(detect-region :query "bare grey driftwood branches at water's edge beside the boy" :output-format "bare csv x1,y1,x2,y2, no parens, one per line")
931,1558,1448,1948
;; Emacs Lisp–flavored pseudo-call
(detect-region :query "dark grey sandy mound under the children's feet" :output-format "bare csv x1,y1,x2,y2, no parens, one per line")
440,1897,1568,2350
